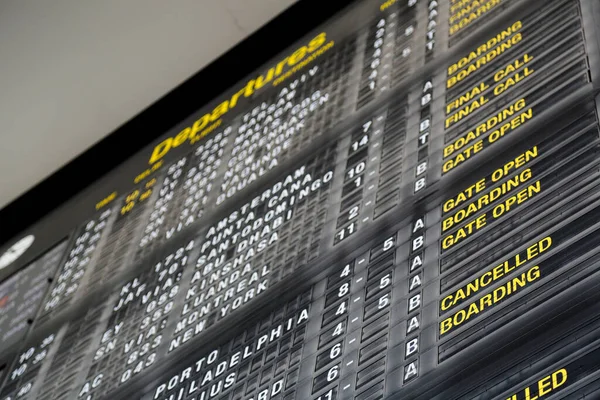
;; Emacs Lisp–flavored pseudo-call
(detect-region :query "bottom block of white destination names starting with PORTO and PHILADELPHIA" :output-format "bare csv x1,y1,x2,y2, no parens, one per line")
141,290,311,400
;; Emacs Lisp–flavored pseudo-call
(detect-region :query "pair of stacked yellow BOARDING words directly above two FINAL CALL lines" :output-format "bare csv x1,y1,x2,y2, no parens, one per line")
446,21,523,84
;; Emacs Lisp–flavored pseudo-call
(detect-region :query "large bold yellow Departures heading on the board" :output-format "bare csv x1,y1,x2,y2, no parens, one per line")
148,32,333,165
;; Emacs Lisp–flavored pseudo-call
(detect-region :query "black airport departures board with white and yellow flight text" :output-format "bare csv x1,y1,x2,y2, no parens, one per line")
0,0,600,400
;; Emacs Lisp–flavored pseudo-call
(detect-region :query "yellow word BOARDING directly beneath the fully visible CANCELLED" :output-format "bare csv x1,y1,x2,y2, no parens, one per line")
440,265,541,336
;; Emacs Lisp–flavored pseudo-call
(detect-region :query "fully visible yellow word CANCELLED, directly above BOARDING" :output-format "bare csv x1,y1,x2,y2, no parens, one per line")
440,236,552,311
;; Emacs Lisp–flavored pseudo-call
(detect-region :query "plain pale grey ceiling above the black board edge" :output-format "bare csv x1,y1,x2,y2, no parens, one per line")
0,0,295,208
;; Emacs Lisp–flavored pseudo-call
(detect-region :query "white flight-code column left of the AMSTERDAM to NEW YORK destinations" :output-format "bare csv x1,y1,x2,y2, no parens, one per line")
76,240,195,398
